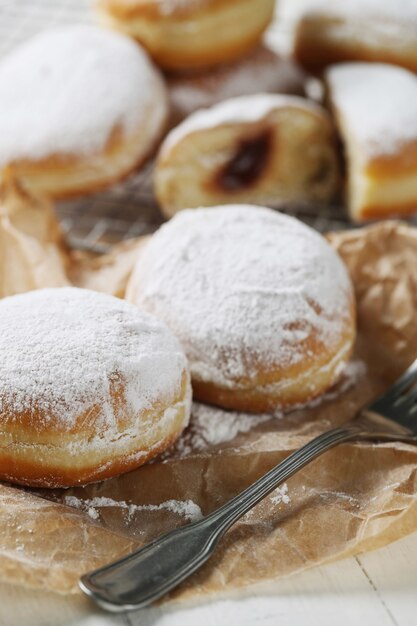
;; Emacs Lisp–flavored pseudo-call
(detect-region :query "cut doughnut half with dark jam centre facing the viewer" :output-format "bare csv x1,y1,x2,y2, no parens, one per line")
155,94,339,216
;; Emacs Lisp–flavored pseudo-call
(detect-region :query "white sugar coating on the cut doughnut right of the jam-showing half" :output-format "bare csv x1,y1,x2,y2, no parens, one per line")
326,63,417,155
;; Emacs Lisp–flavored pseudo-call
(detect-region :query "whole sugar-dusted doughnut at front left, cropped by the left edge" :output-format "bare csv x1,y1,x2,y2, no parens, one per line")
0,288,190,487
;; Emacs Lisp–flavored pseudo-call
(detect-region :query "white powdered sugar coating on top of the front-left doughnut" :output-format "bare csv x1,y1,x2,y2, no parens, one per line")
0,287,187,431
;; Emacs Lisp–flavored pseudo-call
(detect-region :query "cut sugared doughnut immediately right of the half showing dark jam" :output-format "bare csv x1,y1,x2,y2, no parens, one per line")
326,63,417,222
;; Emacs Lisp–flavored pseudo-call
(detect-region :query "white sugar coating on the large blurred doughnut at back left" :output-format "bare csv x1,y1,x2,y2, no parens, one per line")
0,25,166,166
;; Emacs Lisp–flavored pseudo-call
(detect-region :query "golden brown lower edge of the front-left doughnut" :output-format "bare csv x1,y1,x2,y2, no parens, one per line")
0,373,189,488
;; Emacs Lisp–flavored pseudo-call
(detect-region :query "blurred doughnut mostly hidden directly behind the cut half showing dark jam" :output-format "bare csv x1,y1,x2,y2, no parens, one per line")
167,45,307,125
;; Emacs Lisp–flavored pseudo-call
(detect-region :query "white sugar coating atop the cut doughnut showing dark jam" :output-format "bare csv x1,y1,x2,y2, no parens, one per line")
161,93,327,154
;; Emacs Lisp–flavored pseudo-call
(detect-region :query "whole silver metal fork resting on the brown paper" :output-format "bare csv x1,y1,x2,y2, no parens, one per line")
80,360,417,612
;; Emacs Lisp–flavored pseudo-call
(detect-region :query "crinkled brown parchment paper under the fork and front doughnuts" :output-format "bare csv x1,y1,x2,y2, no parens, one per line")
0,189,417,599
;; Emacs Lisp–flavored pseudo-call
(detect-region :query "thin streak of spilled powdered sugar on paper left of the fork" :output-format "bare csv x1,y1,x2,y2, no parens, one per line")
64,496,203,522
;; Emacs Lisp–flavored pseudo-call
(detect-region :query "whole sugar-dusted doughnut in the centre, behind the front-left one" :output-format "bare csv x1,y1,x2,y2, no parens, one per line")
127,206,355,412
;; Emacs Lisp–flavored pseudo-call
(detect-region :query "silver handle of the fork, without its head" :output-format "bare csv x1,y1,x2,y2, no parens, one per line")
80,422,362,612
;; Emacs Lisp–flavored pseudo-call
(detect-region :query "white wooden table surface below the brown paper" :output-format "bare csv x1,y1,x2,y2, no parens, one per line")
4,533,417,626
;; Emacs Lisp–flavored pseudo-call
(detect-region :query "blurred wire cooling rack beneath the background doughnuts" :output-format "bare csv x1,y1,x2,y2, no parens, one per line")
0,0,370,252
